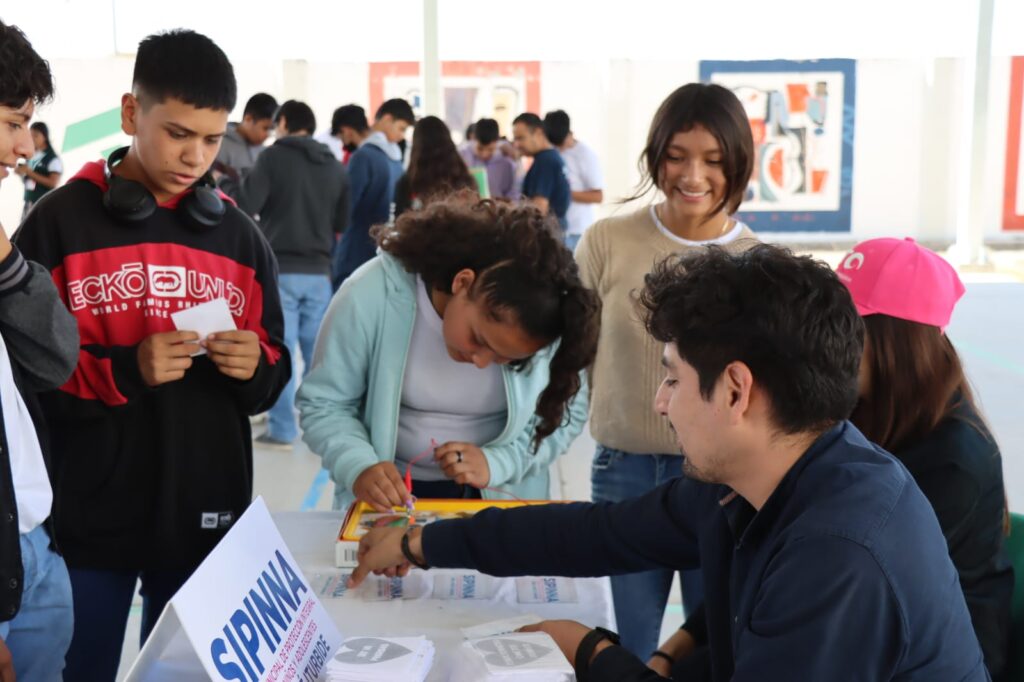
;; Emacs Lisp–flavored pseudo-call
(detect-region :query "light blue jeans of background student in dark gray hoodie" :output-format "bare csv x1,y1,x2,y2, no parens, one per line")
267,272,331,442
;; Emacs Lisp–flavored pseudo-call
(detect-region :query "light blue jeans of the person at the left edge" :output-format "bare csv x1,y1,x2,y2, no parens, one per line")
0,526,73,682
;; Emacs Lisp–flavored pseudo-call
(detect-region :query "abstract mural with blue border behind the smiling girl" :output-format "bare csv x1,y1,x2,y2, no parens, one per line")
700,59,857,232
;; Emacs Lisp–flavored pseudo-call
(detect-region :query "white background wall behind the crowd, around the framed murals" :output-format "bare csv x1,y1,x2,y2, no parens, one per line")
0,56,1020,242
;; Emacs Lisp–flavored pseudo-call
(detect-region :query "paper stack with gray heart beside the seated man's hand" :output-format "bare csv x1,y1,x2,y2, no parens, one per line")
452,632,575,682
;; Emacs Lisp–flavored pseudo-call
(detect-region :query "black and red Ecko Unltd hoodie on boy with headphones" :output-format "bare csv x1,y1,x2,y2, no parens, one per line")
14,163,292,569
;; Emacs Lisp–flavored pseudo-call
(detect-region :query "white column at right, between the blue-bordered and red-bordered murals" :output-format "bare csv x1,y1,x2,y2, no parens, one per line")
949,0,995,265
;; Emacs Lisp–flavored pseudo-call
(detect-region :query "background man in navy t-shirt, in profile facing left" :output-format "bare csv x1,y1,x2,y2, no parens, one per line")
512,114,572,233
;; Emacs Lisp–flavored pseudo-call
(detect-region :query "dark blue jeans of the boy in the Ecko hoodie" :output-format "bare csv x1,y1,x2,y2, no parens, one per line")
65,568,191,682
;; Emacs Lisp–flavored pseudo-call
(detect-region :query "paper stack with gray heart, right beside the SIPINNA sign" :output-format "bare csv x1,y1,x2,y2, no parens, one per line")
324,637,434,682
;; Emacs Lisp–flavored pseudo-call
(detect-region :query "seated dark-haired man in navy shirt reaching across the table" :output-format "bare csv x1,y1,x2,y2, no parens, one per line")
352,245,988,682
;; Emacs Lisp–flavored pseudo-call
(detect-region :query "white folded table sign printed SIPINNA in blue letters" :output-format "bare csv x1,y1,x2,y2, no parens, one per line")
127,498,341,682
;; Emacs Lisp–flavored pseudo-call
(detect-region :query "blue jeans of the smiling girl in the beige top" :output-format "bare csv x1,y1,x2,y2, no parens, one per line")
591,444,703,660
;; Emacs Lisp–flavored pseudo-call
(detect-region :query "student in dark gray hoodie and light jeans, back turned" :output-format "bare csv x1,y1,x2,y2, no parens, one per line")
239,99,349,449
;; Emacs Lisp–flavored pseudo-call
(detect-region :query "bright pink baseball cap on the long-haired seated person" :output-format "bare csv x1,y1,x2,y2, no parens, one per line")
836,238,965,329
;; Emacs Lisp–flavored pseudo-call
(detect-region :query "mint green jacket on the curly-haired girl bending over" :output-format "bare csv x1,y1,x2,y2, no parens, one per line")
296,253,589,509
